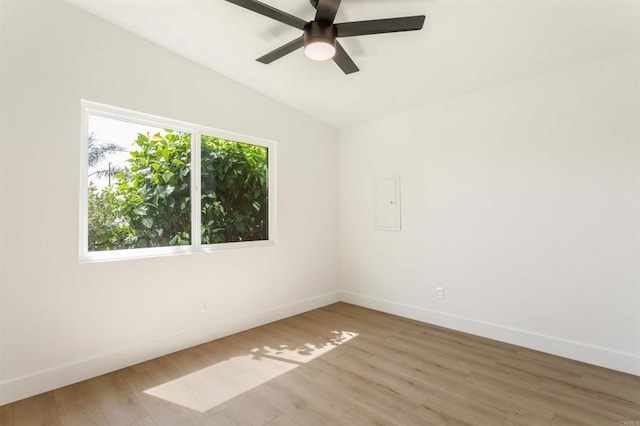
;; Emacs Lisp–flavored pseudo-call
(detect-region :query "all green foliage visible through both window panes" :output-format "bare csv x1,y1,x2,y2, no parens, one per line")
88,130,268,251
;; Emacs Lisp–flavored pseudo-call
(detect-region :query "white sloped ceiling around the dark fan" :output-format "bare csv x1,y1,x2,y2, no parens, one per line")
67,0,640,127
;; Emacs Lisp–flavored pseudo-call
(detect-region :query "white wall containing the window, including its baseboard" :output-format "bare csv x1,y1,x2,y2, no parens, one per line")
0,1,338,404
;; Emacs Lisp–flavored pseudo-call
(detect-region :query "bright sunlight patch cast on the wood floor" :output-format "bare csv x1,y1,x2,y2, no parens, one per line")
144,331,358,413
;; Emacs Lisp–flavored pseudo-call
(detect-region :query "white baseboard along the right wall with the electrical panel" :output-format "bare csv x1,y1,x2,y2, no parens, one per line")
340,291,640,376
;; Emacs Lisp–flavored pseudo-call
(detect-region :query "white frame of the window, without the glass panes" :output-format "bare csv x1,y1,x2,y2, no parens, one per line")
80,99,277,262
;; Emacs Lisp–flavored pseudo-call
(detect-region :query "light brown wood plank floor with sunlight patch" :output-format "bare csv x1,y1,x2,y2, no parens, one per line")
0,303,640,426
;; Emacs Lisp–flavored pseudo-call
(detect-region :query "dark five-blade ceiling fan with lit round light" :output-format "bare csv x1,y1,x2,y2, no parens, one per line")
227,0,425,74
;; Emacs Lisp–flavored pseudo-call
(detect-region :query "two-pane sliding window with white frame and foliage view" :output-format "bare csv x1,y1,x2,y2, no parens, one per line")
80,101,275,260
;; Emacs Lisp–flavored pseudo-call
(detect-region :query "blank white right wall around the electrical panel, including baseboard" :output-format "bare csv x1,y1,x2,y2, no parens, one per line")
339,50,640,374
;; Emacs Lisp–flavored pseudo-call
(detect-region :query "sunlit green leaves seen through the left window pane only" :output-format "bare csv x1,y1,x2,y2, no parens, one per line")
89,130,191,250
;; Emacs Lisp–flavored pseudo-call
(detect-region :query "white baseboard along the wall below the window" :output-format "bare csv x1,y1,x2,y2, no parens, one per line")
0,292,340,405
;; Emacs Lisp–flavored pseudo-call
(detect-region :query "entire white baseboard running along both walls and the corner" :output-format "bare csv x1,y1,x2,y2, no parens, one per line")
0,291,640,405
